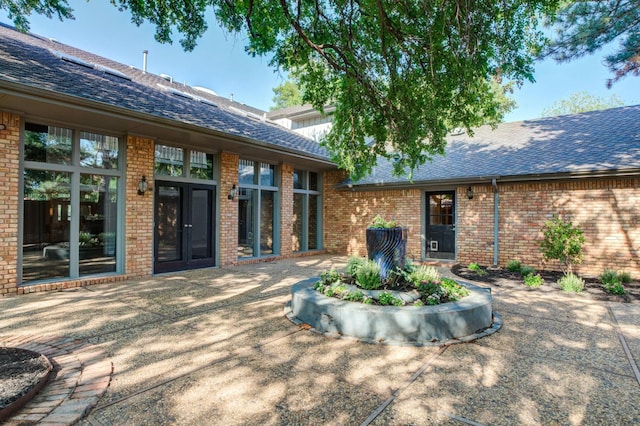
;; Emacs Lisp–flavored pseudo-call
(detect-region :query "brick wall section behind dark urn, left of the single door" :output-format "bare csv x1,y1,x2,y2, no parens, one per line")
323,172,423,260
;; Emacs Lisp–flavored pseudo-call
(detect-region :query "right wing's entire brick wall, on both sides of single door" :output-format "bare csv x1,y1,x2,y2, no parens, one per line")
324,172,640,277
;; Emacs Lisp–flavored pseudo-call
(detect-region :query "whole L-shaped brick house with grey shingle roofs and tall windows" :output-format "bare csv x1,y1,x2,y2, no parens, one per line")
0,24,640,295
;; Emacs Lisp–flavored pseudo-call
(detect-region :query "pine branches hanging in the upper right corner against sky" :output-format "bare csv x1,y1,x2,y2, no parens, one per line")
545,0,640,87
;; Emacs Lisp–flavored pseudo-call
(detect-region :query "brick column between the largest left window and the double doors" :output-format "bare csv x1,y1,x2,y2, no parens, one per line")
125,136,154,276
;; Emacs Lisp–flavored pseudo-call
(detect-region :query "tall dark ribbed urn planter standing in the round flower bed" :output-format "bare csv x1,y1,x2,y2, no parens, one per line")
366,227,408,279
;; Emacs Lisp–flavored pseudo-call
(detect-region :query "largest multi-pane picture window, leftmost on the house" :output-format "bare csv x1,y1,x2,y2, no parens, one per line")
21,123,122,284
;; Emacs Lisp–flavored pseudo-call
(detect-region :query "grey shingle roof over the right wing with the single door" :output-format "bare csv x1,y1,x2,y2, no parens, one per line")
348,105,640,185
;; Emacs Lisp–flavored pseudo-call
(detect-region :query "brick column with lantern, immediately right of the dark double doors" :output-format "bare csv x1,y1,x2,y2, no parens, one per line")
218,152,239,266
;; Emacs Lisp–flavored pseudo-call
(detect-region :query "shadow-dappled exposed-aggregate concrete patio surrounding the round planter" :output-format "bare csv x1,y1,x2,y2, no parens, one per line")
0,256,640,425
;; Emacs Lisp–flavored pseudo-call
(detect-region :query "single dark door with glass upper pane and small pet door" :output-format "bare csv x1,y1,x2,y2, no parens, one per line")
426,192,456,259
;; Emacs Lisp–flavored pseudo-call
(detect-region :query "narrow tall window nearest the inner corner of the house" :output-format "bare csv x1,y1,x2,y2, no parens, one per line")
292,170,322,251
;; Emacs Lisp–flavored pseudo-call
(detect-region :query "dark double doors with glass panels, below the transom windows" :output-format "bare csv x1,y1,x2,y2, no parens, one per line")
154,182,215,273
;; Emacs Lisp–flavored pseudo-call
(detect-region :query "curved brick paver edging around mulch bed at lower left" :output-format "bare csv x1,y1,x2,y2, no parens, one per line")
0,336,113,425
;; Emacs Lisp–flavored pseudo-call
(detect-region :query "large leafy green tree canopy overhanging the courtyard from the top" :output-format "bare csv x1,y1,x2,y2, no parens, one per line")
0,0,560,179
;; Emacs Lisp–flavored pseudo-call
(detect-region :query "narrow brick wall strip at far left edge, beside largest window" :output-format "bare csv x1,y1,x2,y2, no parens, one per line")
0,111,20,296
